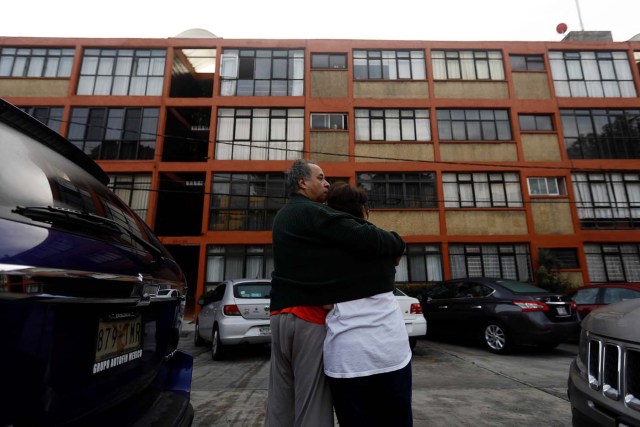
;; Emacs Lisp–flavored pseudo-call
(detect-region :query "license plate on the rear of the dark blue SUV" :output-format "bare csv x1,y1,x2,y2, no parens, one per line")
95,315,142,363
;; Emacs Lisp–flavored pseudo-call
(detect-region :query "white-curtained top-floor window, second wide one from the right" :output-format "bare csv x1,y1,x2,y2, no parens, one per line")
431,50,505,80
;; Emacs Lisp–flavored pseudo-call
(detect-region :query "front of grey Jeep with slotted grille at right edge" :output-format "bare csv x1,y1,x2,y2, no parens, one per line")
567,298,640,427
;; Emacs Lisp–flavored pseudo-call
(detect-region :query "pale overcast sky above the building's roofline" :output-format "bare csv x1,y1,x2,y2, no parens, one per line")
5,0,640,41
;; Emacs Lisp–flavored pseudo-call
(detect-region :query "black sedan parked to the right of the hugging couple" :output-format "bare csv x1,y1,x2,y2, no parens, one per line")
421,278,580,353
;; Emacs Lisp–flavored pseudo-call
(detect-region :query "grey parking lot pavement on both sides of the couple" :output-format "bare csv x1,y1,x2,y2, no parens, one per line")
180,324,577,427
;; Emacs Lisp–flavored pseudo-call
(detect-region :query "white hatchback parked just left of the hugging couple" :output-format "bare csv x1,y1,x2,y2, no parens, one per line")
194,279,271,360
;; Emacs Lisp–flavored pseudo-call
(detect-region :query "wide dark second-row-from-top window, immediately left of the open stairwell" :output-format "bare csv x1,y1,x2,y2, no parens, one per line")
69,108,159,160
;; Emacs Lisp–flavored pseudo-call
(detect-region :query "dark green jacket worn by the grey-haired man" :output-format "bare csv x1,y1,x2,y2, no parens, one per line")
271,194,405,310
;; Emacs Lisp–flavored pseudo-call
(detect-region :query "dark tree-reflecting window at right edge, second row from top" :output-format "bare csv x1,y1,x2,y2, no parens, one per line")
560,109,640,159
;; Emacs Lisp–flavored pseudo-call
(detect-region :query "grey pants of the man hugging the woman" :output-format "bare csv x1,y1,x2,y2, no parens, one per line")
265,313,333,427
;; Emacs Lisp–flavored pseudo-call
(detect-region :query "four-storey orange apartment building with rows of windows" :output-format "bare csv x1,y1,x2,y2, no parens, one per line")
0,30,640,315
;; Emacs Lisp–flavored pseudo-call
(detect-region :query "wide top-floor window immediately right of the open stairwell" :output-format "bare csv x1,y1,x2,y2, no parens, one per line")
220,49,304,96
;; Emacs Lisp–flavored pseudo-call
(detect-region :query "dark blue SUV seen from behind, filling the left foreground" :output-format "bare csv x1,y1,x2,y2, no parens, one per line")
0,100,193,426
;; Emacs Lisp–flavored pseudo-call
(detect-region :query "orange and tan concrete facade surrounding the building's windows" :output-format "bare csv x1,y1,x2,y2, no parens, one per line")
0,37,640,313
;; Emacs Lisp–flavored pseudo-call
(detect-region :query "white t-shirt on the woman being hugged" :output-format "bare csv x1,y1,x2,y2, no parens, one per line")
324,292,411,378
